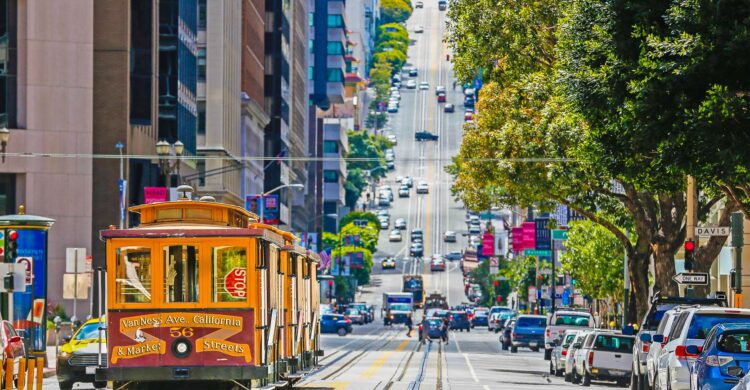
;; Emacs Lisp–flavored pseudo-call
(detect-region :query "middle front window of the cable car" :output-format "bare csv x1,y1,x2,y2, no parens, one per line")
164,245,198,303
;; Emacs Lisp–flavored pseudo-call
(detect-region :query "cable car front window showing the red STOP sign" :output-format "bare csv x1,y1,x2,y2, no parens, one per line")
211,246,248,302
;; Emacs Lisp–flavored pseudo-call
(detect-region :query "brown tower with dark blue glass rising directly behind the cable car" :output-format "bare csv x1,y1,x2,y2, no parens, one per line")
93,0,198,265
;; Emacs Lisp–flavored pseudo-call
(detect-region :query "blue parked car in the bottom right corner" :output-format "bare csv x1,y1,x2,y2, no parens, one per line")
686,324,750,389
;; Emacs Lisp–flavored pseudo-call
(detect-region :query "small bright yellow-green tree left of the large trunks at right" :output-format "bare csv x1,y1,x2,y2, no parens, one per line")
560,221,624,301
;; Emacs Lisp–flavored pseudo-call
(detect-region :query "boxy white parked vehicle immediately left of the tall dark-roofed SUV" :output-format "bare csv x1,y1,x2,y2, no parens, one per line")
573,330,635,386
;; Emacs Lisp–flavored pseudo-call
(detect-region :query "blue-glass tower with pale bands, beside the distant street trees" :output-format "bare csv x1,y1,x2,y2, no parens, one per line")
308,0,348,231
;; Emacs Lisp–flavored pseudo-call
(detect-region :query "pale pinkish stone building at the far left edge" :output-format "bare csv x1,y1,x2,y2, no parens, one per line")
0,0,94,318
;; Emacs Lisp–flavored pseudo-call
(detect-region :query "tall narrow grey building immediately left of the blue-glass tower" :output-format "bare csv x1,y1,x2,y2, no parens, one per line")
264,0,309,231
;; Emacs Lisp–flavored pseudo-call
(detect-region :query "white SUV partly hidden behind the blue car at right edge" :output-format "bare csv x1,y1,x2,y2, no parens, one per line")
654,306,750,390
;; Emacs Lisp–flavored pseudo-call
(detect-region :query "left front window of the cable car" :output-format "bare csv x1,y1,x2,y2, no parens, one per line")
115,246,151,303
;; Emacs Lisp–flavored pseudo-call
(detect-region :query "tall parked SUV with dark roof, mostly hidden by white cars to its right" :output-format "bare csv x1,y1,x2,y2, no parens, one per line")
630,294,727,390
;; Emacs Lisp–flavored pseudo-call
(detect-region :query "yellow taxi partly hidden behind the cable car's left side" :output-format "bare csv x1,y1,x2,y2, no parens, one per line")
57,317,107,390
